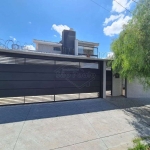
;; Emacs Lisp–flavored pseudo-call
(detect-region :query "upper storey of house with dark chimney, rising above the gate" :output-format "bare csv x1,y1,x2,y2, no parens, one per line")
33,29,99,58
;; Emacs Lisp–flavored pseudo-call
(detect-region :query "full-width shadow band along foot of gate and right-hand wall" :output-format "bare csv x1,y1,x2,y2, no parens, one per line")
0,98,150,125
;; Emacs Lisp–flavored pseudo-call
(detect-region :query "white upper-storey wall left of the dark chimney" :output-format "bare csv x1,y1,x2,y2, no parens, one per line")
36,44,61,54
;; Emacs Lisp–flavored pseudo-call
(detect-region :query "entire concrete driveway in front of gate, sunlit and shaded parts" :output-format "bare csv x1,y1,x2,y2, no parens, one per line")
0,98,150,150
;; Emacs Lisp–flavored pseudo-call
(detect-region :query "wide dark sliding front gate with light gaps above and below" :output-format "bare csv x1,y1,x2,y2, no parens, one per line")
0,50,103,105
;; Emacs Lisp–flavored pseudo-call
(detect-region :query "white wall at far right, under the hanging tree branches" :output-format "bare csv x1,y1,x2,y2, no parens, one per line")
127,80,150,98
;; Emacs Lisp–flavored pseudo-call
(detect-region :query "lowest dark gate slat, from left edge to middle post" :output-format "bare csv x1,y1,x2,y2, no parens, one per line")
0,88,54,97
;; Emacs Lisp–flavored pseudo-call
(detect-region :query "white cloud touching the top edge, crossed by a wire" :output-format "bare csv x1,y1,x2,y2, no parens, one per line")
112,0,133,13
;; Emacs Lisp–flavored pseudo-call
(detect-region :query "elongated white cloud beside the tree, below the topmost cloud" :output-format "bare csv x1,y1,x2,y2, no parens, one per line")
104,16,131,36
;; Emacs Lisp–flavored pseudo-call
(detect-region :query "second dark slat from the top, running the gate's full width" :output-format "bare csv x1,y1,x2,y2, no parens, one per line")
0,72,100,81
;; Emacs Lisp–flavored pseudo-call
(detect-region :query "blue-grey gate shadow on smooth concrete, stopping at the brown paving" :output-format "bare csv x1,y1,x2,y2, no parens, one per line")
0,99,117,124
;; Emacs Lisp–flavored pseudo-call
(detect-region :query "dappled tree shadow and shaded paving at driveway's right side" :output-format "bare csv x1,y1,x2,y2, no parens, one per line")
107,97,150,140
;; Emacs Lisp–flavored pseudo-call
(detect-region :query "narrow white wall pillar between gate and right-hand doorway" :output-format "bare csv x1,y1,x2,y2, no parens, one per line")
112,76,122,96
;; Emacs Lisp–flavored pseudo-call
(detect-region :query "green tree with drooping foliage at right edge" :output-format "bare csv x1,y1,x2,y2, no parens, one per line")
111,0,150,88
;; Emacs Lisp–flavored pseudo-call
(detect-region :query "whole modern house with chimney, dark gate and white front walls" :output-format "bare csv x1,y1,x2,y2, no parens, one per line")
0,30,150,104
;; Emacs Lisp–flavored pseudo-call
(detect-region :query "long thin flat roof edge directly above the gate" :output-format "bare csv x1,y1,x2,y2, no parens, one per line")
0,48,110,61
